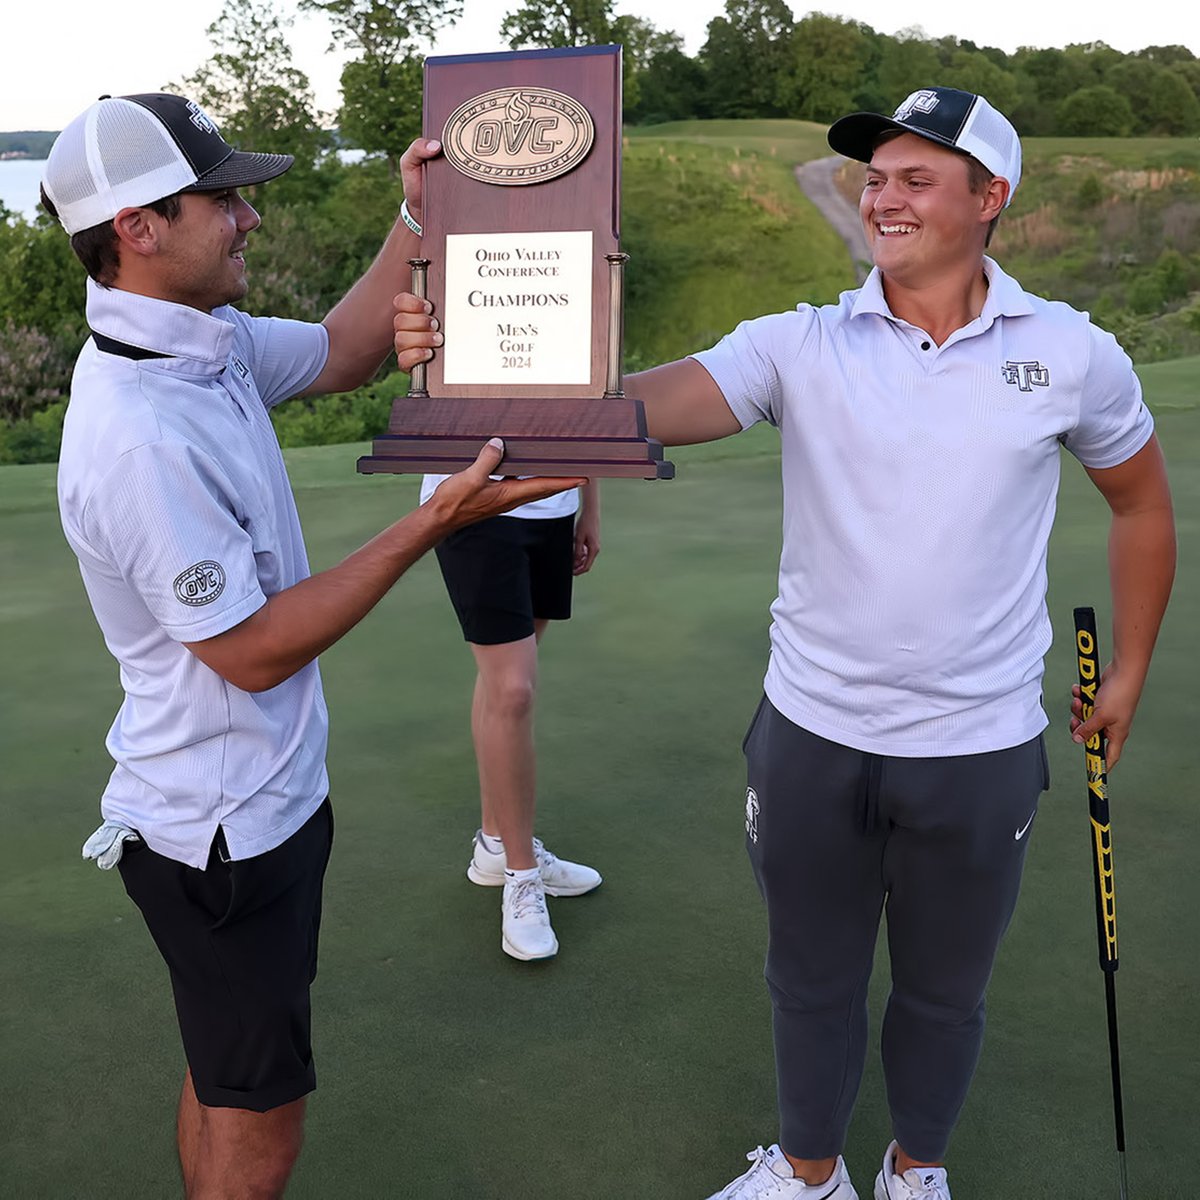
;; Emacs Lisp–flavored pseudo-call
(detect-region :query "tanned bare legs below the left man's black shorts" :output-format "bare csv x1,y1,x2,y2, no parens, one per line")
179,1073,305,1200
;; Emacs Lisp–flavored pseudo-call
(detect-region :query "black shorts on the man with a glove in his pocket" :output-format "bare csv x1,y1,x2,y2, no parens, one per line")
120,798,334,1112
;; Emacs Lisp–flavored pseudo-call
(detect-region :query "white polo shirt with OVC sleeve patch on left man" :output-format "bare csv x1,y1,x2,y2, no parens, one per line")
59,281,329,868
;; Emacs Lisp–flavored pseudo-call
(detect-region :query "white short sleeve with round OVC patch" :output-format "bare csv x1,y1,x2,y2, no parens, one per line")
82,442,266,642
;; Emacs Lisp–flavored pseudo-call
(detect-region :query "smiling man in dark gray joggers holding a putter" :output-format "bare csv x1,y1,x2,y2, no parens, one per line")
396,88,1175,1200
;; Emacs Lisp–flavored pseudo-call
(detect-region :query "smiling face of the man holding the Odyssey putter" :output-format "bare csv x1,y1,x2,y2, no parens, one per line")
858,133,1008,288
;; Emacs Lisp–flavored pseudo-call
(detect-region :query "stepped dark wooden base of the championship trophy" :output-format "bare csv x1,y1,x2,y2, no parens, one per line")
358,396,674,479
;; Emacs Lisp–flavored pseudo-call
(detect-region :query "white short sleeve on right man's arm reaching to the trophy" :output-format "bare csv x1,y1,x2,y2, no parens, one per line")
692,305,817,430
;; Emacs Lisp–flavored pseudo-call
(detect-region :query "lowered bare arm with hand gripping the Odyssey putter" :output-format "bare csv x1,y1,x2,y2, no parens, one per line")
1070,437,1175,767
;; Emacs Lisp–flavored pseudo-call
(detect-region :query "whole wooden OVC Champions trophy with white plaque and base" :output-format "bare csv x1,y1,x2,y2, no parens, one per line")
358,46,674,479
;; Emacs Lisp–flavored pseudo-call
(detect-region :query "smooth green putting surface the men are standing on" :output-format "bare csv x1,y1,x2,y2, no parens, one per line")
0,381,1200,1200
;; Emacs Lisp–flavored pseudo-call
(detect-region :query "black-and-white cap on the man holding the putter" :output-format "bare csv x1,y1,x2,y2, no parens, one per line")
829,88,1021,206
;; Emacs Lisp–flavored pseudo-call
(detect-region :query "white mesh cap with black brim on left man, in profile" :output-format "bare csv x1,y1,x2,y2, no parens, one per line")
42,92,295,234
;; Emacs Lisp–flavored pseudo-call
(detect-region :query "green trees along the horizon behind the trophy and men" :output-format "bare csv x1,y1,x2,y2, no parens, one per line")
169,0,1200,180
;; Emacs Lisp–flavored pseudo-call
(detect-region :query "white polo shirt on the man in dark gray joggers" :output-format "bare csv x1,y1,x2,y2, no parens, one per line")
696,259,1153,757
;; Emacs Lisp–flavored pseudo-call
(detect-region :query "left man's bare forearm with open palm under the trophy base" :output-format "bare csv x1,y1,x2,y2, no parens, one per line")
184,439,586,691
